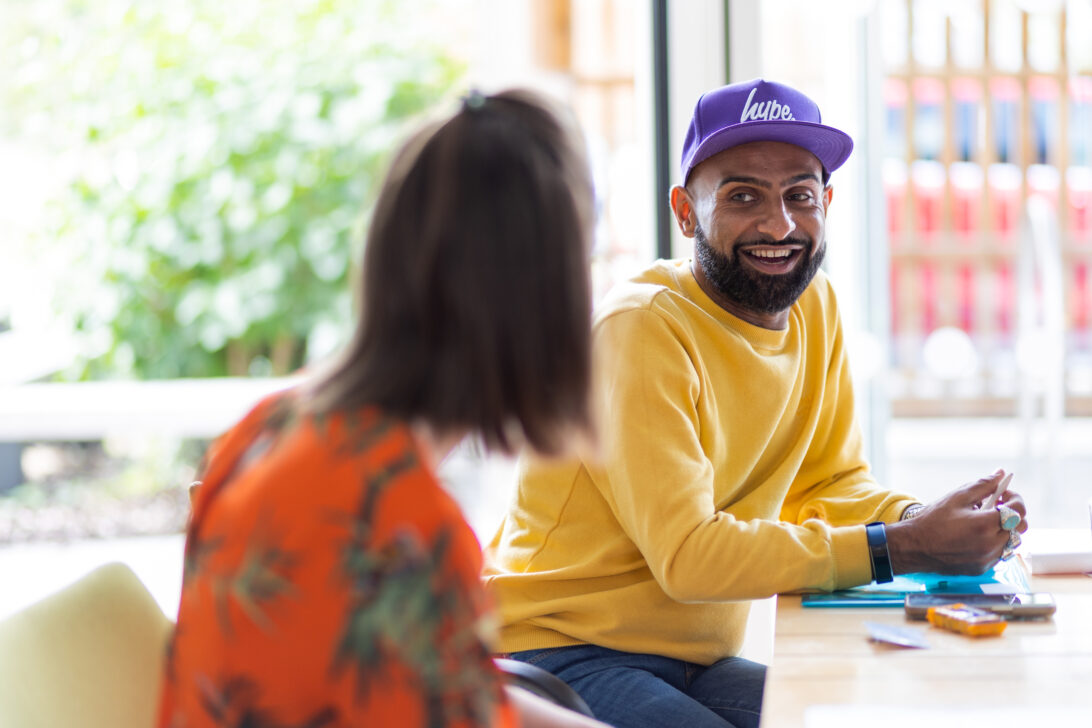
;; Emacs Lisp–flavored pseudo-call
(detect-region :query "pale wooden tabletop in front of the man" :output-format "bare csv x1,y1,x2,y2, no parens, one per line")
762,563,1092,728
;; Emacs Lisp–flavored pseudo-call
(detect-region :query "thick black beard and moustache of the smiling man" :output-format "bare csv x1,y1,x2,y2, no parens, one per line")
693,225,827,313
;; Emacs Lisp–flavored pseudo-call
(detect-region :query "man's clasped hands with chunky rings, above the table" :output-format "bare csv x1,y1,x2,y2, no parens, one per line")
887,470,1028,574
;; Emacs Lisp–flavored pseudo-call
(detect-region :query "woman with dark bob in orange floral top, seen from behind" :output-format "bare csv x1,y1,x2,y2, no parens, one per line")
159,92,601,728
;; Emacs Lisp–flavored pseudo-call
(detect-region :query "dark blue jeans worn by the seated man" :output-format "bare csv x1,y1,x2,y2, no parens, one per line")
509,645,765,728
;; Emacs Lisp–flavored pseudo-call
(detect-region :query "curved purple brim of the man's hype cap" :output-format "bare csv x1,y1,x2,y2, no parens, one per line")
683,121,853,184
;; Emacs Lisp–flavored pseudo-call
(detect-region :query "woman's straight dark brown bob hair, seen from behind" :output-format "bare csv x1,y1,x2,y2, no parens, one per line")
311,91,593,454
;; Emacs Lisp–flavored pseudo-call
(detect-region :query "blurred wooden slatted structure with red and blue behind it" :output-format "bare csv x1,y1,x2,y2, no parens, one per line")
885,0,1092,416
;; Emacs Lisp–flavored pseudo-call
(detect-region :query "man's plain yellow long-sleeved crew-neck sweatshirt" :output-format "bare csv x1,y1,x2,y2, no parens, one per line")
485,261,915,665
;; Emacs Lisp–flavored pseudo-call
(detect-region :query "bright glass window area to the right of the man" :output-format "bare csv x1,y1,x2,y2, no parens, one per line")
729,0,1092,527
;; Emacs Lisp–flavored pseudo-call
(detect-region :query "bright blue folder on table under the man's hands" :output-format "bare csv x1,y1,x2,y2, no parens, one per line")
800,559,1031,607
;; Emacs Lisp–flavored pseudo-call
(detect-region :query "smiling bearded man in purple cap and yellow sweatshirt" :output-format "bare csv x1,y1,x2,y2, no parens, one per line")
486,80,1026,726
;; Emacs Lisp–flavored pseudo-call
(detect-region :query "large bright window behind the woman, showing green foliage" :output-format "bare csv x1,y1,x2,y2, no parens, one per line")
0,0,661,544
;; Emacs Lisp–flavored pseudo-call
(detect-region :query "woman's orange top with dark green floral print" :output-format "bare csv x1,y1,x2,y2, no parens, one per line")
158,392,514,728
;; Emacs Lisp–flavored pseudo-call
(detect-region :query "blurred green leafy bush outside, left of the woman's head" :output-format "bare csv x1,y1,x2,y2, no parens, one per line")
0,0,463,378
